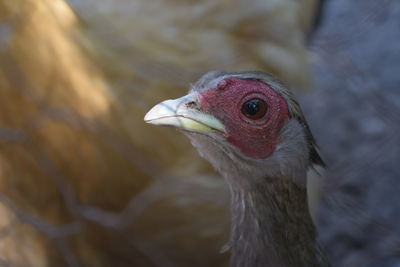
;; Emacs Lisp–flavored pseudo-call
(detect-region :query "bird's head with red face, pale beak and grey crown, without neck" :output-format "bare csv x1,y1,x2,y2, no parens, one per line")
144,72,323,182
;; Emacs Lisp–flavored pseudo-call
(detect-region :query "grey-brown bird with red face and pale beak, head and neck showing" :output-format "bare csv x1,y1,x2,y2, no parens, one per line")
144,71,330,267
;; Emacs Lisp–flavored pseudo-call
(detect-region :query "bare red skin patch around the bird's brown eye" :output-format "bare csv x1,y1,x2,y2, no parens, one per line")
199,78,289,159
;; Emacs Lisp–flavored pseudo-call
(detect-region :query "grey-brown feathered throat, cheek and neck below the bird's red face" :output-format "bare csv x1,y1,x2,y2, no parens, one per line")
186,122,329,267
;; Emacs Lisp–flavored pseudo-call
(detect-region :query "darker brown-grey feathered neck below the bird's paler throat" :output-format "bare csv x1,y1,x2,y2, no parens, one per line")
225,177,328,267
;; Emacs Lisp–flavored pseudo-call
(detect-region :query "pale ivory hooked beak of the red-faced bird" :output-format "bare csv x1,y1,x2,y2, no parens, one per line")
144,93,225,133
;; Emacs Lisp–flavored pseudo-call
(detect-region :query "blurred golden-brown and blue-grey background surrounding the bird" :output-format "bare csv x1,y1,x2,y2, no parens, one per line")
0,0,400,267
